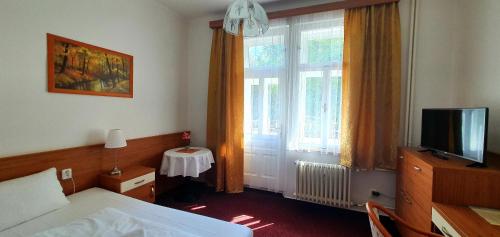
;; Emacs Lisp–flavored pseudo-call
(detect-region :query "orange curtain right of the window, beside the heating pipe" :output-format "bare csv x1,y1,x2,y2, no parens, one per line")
340,3,401,170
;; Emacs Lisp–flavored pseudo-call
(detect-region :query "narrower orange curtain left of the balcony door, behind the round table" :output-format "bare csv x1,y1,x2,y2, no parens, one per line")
207,29,244,193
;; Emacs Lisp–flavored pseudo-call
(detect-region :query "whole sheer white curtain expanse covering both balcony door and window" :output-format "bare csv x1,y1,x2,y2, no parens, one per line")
244,11,343,192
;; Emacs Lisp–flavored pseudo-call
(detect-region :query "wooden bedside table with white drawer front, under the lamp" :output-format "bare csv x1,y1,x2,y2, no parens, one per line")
99,166,155,203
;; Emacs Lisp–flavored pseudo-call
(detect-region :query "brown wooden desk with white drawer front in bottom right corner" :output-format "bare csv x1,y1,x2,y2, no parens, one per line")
432,203,500,237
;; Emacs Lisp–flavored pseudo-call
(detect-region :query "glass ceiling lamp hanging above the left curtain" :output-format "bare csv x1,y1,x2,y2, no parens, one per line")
224,0,269,37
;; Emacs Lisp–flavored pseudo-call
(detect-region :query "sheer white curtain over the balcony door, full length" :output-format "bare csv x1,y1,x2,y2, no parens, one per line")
244,20,289,192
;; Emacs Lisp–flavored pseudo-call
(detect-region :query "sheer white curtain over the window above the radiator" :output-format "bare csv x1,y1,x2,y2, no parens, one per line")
287,11,344,154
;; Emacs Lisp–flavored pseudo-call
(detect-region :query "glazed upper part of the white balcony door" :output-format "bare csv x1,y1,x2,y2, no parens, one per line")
245,25,288,138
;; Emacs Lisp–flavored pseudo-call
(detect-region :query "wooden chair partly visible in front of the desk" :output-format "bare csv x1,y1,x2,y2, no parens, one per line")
366,201,442,237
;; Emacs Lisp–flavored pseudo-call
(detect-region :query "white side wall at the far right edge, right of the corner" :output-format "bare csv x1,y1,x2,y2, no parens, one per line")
456,0,500,153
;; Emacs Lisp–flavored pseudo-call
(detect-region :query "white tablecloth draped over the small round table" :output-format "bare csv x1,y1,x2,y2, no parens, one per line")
160,147,215,178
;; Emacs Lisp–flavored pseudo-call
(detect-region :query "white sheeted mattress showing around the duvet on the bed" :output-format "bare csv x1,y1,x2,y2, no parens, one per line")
0,188,253,237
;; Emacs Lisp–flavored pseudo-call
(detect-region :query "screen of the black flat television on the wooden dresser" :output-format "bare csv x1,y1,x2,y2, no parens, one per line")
421,108,488,163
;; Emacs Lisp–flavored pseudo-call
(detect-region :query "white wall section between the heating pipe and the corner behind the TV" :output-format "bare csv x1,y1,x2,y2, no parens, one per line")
409,0,458,146
